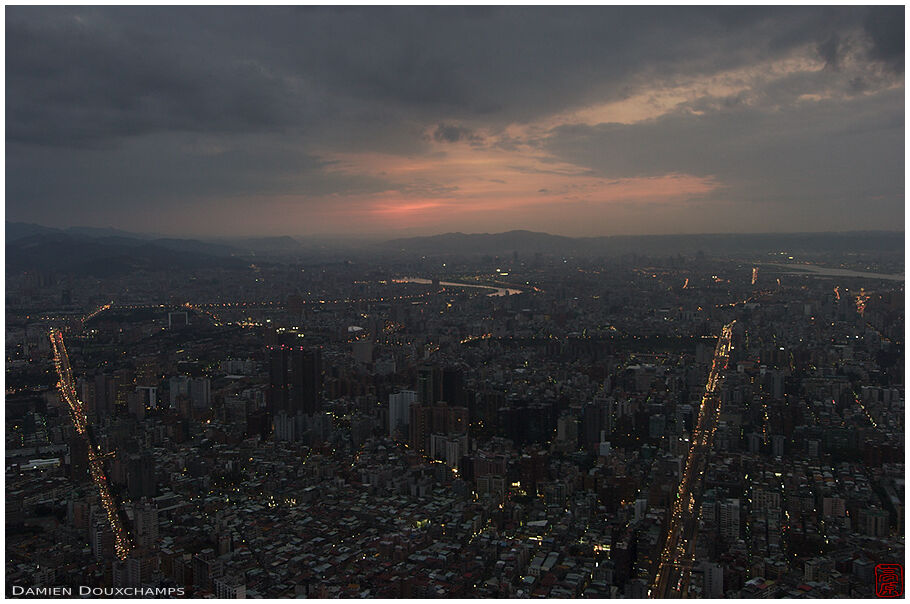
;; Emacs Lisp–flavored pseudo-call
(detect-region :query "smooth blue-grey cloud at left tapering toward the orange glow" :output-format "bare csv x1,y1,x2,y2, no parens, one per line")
7,134,389,212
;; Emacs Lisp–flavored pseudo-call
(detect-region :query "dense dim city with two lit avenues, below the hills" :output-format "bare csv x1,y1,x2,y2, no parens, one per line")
6,234,904,598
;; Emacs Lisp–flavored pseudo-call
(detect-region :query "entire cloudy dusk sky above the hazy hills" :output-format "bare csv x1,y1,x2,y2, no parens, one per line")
5,6,904,238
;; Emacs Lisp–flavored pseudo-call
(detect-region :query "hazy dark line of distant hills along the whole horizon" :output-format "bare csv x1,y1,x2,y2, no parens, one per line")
6,222,904,266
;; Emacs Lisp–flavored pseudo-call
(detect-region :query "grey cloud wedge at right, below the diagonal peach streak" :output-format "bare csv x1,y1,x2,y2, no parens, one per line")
547,91,904,222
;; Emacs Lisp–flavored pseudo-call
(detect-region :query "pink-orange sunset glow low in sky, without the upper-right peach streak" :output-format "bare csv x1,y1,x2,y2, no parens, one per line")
325,143,720,226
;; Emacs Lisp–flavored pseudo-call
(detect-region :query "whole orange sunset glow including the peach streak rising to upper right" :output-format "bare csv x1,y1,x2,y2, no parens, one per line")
258,45,864,234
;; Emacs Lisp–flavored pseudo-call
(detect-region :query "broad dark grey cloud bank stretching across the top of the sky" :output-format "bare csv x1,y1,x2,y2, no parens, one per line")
7,7,903,144
